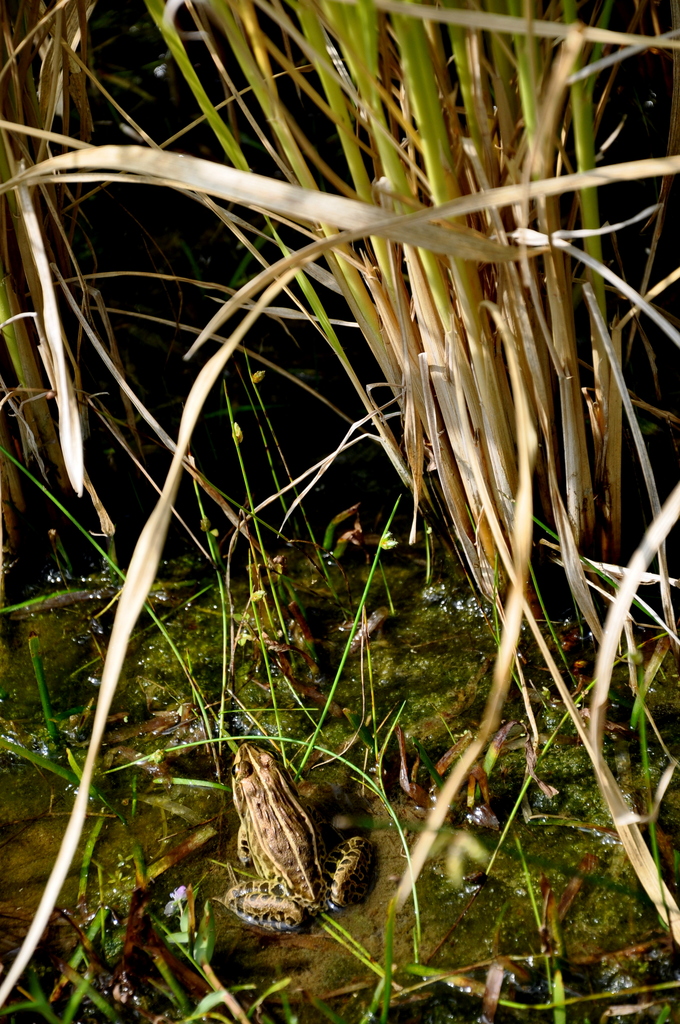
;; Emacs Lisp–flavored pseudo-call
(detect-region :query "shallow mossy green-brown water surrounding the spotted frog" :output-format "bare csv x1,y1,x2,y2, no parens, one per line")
0,546,680,1024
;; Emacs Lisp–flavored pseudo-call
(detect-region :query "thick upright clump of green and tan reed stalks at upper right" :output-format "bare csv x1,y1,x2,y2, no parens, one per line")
150,3,677,614
